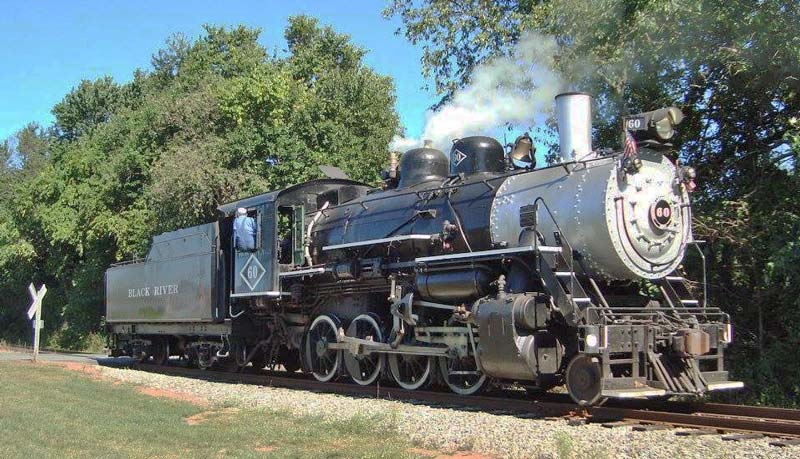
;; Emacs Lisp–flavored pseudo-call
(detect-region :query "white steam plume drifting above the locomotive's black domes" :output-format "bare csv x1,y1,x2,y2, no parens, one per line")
389,33,562,152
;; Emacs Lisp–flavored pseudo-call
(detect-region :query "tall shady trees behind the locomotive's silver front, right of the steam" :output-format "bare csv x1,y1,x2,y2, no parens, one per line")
384,0,800,404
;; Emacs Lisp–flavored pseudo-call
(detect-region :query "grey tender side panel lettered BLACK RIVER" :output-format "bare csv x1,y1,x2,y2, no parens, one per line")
106,223,224,323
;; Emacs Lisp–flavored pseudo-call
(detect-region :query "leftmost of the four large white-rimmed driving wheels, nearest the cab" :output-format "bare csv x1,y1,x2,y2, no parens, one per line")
305,315,342,382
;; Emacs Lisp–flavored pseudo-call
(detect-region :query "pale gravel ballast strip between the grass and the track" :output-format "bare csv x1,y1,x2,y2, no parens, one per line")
95,367,800,459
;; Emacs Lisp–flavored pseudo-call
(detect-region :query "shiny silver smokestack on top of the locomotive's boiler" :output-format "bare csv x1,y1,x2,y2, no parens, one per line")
556,92,592,162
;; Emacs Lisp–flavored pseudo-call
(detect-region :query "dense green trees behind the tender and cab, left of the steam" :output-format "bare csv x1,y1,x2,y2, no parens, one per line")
0,17,398,348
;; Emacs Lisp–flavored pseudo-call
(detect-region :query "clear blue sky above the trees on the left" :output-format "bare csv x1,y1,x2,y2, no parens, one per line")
0,0,436,139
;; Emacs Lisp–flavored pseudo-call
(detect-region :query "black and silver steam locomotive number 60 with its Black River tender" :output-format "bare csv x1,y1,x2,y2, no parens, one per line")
106,93,742,405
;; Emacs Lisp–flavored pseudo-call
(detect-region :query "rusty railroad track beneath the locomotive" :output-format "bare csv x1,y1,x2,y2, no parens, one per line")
125,364,800,446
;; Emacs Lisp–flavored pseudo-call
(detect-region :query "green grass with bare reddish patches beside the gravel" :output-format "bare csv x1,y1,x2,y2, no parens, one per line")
0,362,422,459
